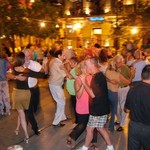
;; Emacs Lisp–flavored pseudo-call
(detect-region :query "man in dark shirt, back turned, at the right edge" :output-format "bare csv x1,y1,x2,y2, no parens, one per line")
125,65,150,150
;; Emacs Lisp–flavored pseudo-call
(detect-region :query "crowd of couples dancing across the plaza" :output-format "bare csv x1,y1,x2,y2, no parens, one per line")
0,41,150,150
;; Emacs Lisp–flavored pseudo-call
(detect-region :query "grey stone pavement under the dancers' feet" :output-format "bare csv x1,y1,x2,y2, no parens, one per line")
0,79,127,150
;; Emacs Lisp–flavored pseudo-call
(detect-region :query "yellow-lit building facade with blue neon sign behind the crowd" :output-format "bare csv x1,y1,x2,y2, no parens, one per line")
59,0,148,47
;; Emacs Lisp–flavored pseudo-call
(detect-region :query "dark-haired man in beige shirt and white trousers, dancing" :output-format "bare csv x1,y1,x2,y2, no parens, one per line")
48,50,67,127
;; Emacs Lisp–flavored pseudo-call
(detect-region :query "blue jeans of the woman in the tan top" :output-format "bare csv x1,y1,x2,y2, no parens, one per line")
108,90,118,131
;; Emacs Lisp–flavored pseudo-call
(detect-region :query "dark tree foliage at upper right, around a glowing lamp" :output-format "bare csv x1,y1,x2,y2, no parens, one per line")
113,2,150,48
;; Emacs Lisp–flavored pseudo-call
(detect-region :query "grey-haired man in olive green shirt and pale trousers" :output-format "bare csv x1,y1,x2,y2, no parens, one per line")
114,55,132,131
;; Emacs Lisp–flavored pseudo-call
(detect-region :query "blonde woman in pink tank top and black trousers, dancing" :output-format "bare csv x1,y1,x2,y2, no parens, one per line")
66,61,97,148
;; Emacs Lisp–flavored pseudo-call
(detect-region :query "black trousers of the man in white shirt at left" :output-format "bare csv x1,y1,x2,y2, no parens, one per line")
25,88,39,131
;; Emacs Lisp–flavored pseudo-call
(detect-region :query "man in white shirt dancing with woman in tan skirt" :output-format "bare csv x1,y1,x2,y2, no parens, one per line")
23,49,44,135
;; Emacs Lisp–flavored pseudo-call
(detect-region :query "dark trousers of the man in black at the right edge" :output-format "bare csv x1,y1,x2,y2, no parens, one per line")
128,121,150,150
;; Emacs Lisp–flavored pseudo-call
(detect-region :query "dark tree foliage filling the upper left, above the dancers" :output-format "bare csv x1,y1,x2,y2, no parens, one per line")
0,0,59,49
